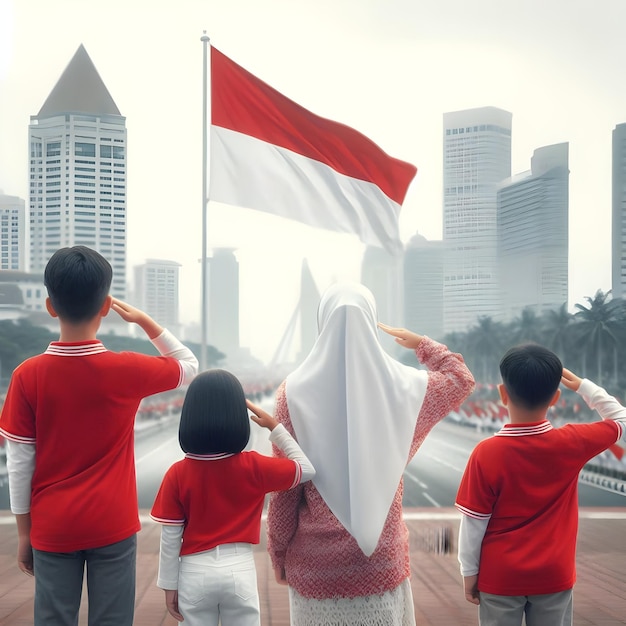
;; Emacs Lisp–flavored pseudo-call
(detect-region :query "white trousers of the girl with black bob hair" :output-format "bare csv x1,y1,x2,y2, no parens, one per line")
178,543,261,626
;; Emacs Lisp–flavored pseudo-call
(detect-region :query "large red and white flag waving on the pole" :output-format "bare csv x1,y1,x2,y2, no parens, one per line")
209,47,417,251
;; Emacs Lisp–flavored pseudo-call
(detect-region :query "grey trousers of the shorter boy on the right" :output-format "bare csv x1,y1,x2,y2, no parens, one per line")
478,589,573,626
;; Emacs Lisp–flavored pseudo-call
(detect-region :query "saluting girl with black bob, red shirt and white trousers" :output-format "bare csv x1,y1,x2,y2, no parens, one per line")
151,369,315,626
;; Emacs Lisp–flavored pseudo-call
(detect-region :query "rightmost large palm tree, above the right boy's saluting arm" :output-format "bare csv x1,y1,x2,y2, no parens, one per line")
574,289,623,385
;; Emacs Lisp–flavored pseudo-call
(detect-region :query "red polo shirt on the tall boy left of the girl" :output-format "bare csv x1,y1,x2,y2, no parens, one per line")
0,340,182,552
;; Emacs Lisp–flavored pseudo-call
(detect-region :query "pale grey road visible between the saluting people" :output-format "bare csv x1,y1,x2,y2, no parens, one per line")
0,418,626,509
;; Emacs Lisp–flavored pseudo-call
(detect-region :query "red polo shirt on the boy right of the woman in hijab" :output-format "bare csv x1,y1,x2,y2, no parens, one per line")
456,420,621,596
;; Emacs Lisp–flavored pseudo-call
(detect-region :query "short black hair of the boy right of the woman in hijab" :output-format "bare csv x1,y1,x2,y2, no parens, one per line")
500,343,563,410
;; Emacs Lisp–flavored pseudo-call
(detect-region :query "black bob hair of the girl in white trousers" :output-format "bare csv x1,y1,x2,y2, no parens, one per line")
178,369,250,454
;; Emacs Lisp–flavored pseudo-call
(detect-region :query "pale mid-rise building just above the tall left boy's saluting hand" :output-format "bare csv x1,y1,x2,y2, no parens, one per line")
134,259,181,336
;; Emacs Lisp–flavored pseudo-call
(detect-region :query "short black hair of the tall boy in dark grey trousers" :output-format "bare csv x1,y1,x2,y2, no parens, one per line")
43,246,113,323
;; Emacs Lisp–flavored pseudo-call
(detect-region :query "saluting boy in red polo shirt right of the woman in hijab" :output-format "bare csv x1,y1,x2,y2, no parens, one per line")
456,344,626,626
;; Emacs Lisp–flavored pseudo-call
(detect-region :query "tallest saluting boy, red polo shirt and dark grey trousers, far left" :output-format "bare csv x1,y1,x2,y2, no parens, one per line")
0,246,198,626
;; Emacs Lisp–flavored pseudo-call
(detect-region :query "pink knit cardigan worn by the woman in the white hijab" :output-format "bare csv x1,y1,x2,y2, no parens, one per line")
267,337,474,599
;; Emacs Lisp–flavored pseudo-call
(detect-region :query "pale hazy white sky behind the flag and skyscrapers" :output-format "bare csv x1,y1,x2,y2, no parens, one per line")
0,0,626,359
